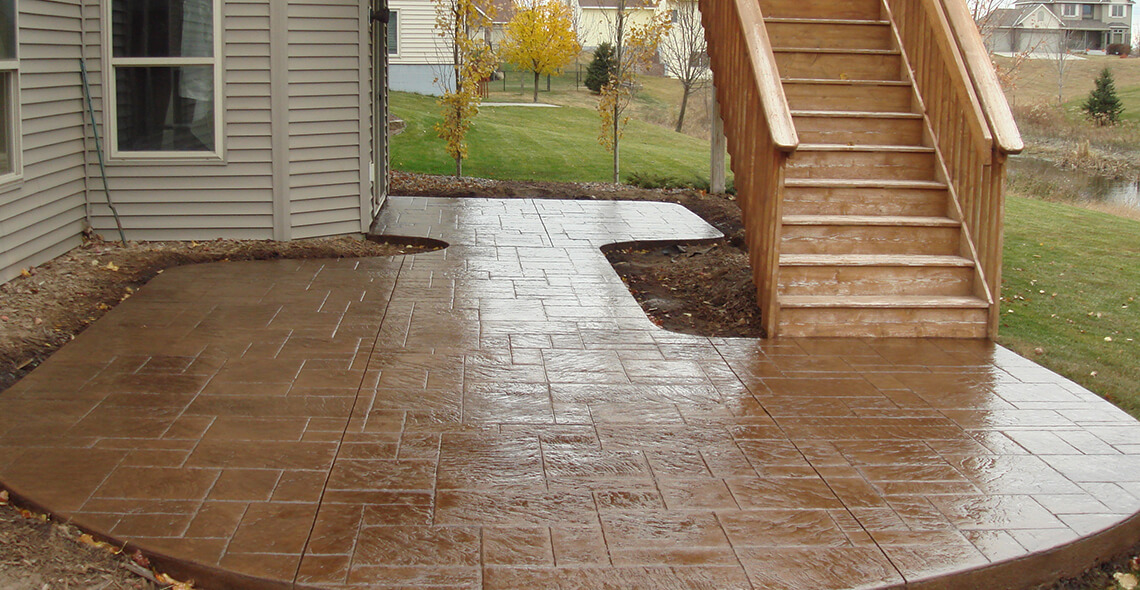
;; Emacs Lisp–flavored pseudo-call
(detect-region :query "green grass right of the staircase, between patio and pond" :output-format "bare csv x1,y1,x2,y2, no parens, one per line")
1000,197,1140,418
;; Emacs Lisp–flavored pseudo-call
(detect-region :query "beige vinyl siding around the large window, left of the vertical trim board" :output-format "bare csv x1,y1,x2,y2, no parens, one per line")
84,0,274,240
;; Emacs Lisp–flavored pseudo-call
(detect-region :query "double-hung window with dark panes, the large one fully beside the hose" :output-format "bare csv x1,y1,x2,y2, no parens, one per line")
108,0,221,157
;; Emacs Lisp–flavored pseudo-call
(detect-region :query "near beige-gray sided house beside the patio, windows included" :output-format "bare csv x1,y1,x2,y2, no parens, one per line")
0,0,386,281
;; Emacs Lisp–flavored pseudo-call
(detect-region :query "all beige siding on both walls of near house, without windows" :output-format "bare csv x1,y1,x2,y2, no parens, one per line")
0,0,372,287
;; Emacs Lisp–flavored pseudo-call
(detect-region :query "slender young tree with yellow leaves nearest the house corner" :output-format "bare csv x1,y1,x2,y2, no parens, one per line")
435,0,498,177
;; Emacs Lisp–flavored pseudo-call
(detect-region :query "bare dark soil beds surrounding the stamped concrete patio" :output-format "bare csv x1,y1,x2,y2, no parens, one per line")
0,172,1140,590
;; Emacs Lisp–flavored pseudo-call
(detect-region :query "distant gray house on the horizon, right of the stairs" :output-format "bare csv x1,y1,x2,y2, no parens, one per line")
983,0,1135,52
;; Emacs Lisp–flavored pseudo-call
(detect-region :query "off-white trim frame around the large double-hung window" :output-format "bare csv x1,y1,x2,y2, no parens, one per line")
103,0,226,163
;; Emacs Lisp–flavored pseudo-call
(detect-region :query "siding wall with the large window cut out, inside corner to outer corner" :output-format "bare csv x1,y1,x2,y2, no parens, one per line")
84,0,369,240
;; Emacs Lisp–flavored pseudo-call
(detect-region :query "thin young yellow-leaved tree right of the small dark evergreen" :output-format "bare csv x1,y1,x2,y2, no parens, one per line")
597,0,669,185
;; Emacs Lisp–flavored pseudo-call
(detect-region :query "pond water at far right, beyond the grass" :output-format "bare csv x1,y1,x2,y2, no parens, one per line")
1009,156,1140,208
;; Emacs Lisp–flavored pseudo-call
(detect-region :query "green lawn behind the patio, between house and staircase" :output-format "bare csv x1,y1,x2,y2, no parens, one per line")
391,92,709,182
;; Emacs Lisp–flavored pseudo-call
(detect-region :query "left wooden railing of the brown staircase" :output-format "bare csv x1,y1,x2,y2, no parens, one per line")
700,0,799,337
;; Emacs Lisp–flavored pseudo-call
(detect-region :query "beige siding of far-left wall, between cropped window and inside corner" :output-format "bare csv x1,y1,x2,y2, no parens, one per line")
0,0,86,281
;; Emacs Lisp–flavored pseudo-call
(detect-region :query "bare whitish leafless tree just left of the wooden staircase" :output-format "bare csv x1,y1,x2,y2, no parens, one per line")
659,0,709,133
